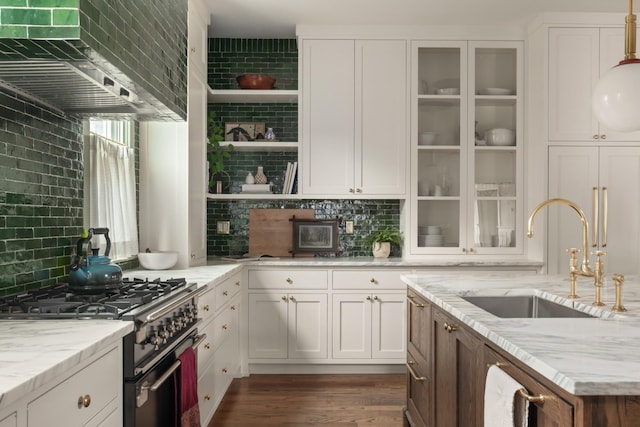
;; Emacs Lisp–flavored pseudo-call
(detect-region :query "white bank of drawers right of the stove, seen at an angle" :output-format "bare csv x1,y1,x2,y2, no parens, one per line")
198,273,242,425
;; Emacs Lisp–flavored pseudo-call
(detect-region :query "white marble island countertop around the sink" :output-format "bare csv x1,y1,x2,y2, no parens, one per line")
402,272,640,395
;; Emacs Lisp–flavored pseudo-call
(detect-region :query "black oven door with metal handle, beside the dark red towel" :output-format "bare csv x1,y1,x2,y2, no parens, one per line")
124,331,206,427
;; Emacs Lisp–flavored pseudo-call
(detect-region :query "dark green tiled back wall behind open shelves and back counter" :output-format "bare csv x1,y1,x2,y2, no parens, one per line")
207,39,400,256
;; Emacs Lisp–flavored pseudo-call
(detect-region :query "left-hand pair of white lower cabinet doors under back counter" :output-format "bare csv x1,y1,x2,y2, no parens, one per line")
249,291,328,360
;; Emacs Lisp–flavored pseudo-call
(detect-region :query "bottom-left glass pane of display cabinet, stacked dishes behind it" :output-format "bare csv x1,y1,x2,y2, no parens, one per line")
418,200,460,248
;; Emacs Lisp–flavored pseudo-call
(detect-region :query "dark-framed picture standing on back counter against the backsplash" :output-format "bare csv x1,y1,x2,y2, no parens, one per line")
291,217,340,256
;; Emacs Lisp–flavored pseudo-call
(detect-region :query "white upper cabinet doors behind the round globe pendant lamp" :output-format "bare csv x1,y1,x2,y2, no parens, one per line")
548,27,640,143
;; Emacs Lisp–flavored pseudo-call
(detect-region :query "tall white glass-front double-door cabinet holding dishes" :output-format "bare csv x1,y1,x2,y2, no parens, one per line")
410,41,524,255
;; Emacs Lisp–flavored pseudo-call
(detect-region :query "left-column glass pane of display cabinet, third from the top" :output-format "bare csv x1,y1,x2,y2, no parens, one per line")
418,149,460,197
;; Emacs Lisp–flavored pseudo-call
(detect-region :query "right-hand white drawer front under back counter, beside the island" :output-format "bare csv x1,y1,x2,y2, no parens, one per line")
333,269,409,291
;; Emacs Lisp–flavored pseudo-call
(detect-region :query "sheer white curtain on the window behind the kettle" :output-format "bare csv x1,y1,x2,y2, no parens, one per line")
85,134,138,260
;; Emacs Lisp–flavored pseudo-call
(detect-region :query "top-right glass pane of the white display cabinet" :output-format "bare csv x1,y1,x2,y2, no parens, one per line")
475,48,518,96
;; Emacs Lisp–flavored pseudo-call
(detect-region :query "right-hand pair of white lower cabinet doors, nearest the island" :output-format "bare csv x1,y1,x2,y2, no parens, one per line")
332,292,407,360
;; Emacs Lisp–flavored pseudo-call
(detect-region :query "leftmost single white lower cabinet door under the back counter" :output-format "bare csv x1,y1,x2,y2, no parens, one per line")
249,292,287,359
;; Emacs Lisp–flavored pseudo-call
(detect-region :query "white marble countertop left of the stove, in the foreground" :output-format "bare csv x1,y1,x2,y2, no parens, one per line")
0,319,133,412
